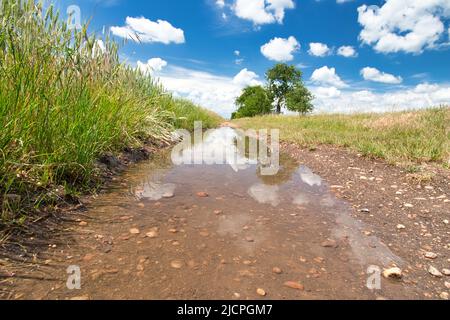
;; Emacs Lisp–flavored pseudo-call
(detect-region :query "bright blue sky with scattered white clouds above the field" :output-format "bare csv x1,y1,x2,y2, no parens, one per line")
56,0,450,116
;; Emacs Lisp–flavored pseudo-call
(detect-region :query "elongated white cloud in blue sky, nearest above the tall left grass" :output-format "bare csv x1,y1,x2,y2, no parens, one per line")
111,17,185,44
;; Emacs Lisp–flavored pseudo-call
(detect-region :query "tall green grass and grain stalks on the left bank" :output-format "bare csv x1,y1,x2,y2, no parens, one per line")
0,0,220,228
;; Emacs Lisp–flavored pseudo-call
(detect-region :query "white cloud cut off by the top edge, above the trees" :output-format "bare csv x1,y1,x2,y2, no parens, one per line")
233,0,295,25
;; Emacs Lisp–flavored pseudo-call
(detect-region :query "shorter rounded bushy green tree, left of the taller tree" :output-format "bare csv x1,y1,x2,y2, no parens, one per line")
232,86,272,119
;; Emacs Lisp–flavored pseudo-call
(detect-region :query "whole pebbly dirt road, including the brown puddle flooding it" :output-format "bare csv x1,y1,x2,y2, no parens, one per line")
0,127,450,300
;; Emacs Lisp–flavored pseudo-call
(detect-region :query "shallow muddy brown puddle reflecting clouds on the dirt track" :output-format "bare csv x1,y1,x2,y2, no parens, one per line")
0,128,413,299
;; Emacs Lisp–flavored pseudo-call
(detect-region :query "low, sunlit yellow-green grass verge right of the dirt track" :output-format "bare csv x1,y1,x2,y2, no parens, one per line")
235,107,450,166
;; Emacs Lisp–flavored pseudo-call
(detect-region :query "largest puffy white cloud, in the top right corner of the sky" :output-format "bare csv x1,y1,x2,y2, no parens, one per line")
358,0,450,54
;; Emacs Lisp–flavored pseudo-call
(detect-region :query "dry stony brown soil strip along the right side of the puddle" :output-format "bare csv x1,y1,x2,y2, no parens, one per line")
282,143,450,299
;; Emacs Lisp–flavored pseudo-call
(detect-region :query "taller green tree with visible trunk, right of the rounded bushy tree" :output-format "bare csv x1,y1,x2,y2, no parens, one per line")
266,63,313,113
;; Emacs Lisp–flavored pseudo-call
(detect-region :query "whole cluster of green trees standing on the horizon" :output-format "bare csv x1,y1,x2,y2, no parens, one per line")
231,63,314,119
